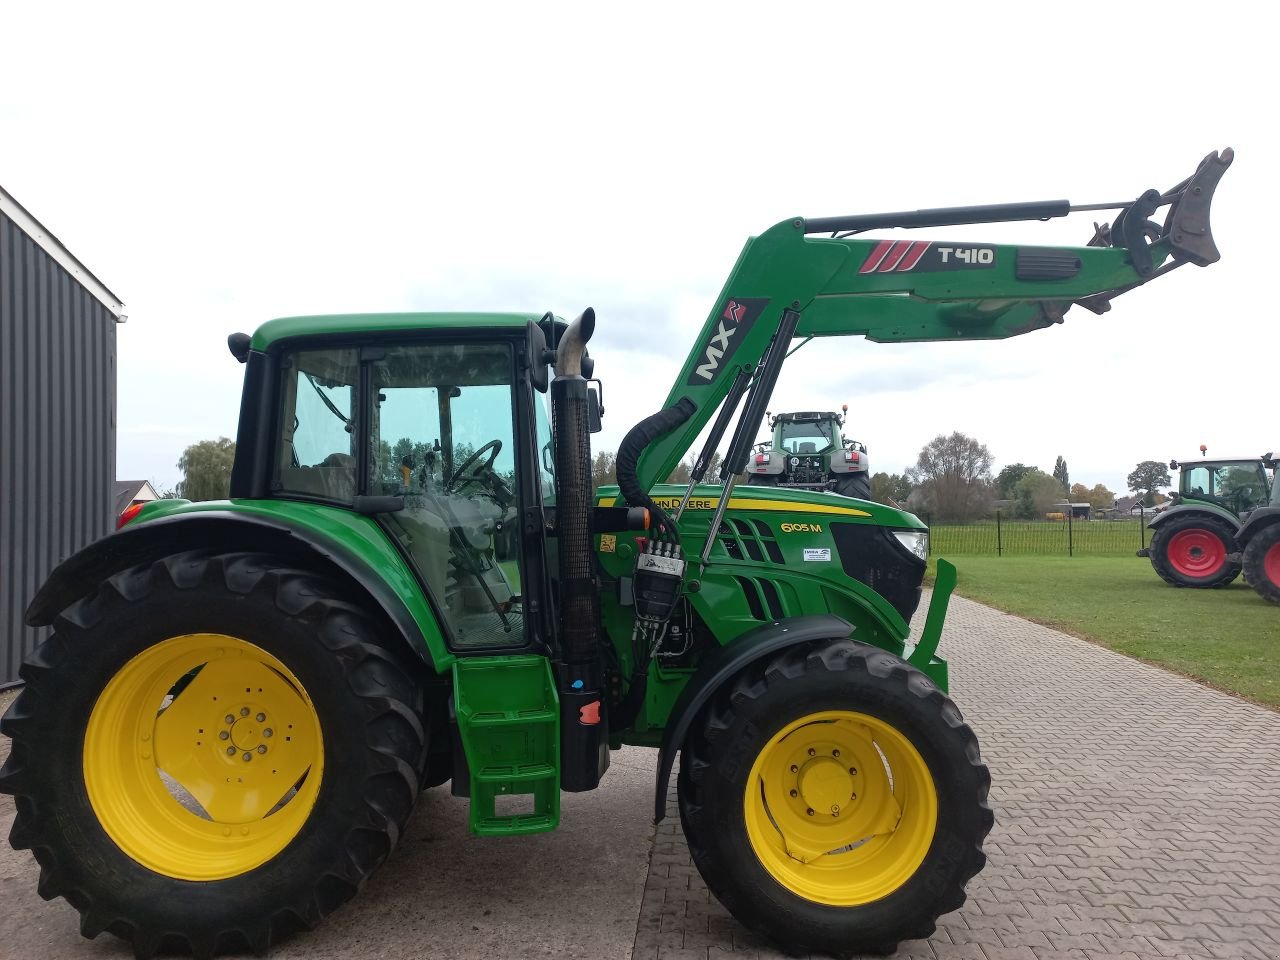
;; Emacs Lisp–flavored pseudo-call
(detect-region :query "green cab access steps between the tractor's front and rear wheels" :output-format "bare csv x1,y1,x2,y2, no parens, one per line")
453,655,559,836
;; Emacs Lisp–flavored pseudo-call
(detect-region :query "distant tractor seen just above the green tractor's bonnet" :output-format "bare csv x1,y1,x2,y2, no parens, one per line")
746,403,872,500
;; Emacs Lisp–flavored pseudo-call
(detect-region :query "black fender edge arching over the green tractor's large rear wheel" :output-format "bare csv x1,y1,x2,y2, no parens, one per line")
26,509,435,668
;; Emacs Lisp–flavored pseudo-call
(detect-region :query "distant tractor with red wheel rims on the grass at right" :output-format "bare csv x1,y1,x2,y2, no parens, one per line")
1138,448,1280,603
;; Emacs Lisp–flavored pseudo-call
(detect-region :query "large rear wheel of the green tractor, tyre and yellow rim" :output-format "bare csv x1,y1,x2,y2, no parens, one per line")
0,552,425,957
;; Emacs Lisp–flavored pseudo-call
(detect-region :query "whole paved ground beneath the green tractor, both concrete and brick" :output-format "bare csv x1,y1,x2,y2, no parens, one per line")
0,599,1280,960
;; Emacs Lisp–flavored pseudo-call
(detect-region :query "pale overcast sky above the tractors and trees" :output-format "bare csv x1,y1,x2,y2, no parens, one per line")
0,0,1280,492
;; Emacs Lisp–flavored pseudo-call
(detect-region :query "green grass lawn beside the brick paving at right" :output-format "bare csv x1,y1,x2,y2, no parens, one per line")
931,557,1280,708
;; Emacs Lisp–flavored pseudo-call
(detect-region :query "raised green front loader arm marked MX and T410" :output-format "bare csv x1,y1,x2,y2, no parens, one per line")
636,148,1234,490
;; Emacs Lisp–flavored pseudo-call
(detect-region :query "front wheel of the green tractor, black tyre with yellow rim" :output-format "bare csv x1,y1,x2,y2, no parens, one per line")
677,640,993,956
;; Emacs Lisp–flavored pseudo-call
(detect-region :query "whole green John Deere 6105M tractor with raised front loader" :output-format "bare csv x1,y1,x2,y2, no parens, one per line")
0,151,1231,957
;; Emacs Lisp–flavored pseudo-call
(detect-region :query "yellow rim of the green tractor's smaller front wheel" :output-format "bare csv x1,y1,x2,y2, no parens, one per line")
744,710,938,906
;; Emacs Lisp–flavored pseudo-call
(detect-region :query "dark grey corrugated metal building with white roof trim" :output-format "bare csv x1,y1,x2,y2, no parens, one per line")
0,188,124,685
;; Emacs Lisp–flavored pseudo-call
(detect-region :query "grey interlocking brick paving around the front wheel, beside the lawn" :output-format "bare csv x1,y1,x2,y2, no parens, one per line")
632,598,1280,960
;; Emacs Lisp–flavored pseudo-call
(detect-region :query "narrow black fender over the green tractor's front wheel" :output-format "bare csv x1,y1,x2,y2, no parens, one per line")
653,613,854,823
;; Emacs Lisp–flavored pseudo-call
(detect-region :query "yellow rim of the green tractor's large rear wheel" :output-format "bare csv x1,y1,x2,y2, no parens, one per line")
84,634,324,881
